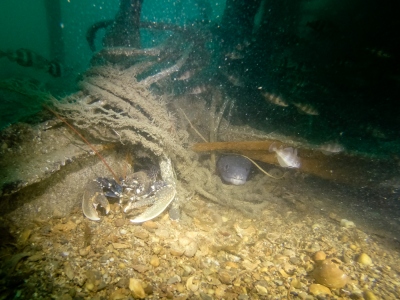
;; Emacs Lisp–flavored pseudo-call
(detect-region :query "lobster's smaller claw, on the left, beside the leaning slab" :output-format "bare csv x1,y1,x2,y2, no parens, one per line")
82,180,110,221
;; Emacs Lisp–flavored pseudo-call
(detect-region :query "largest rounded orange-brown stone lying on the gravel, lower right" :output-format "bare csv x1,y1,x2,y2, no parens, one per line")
312,259,349,289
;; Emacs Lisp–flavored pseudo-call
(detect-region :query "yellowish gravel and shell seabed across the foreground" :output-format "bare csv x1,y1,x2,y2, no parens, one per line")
0,184,400,299
